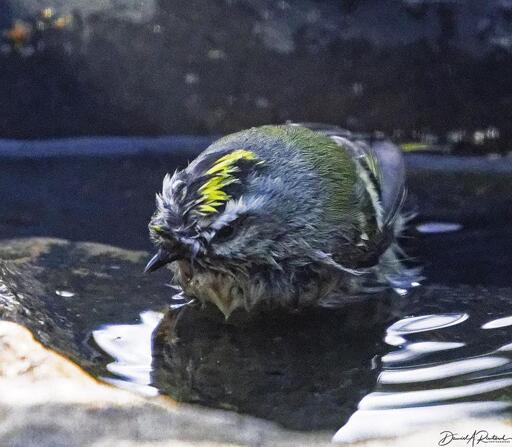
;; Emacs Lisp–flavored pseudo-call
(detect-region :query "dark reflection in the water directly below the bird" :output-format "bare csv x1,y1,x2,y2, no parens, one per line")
152,297,396,430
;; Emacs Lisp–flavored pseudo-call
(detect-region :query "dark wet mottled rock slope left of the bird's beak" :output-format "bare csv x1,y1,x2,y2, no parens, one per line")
0,239,169,374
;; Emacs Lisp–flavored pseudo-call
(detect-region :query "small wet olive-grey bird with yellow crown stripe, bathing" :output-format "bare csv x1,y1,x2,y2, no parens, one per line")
146,124,418,318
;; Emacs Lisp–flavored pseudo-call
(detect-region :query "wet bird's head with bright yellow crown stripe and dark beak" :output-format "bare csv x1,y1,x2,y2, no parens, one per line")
146,149,277,316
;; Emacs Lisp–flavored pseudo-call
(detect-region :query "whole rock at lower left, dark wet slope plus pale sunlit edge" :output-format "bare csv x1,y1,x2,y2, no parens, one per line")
0,239,336,447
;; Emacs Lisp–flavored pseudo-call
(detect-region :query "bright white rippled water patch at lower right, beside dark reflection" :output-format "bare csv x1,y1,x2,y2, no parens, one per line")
335,310,512,442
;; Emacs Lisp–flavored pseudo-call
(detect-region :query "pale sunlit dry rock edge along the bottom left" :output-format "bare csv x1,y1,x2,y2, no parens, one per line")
0,321,329,447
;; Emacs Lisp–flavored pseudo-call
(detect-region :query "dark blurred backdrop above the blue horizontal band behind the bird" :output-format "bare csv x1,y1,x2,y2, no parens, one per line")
0,0,512,150
